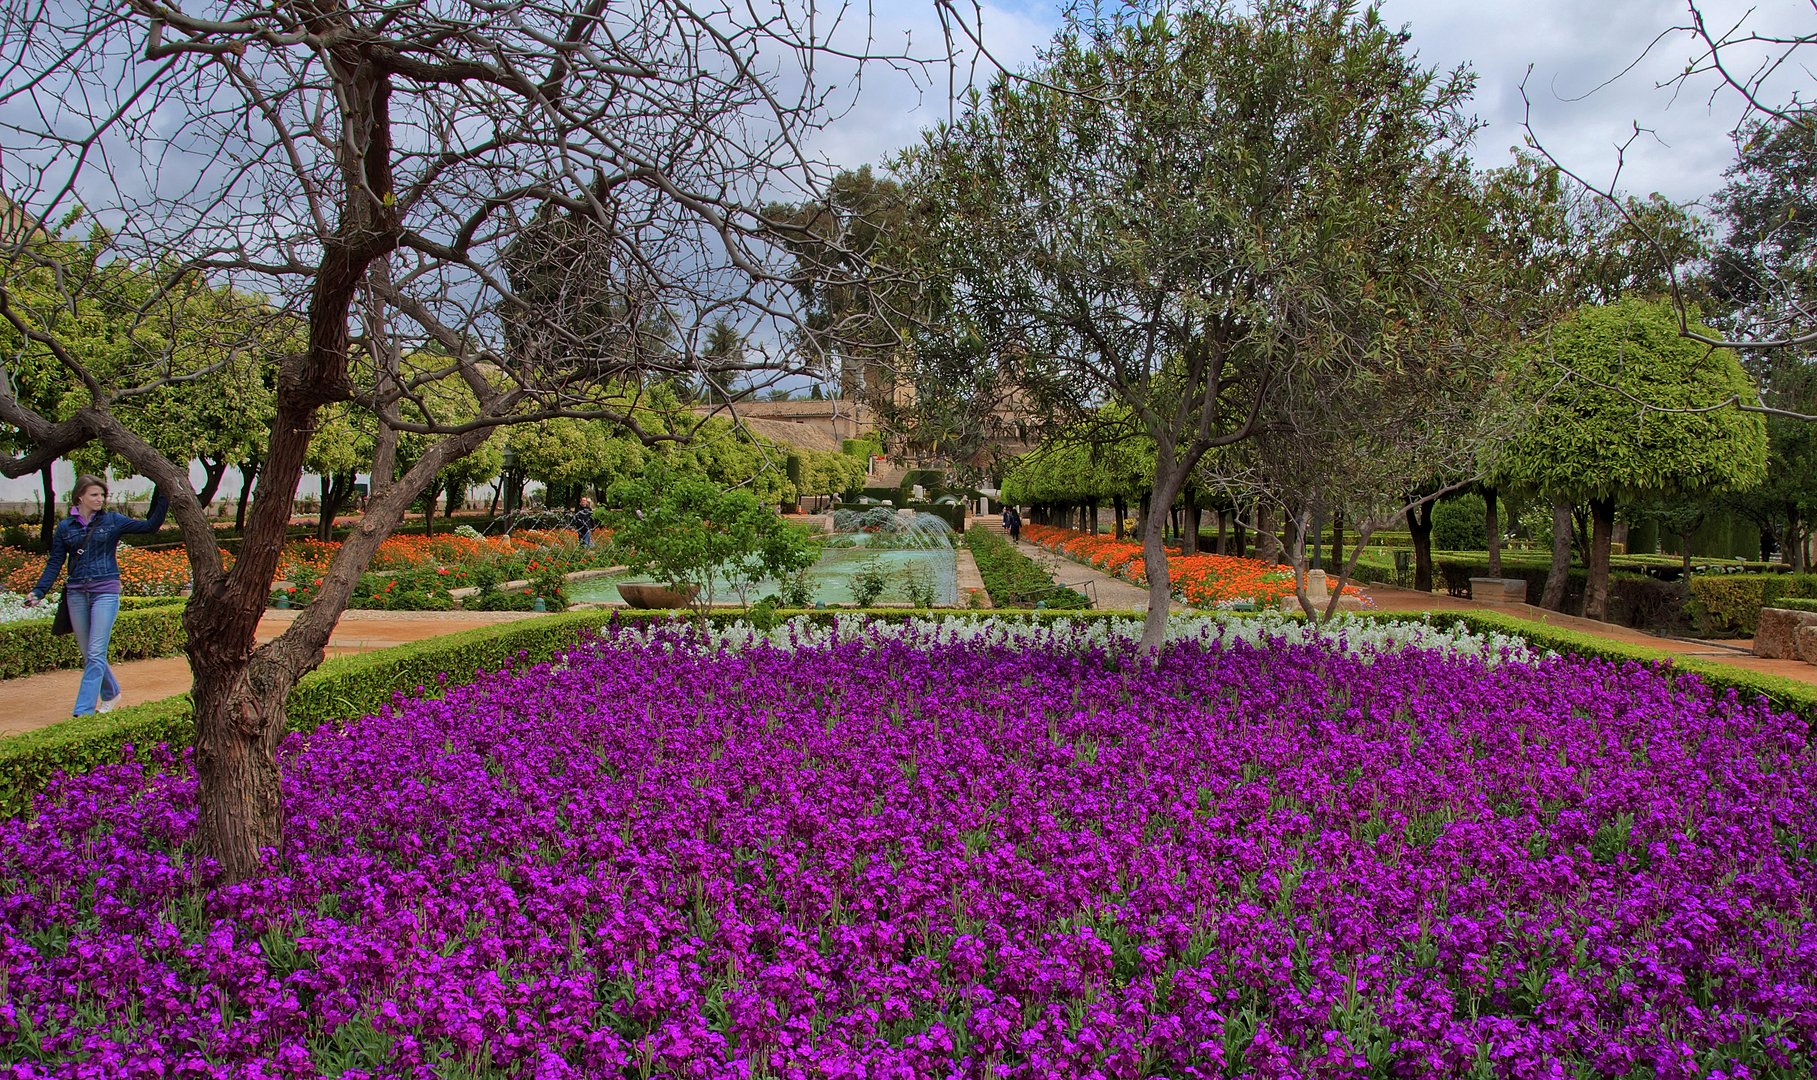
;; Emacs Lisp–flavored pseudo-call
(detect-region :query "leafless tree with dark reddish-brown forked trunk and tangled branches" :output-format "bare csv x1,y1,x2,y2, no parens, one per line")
0,0,948,880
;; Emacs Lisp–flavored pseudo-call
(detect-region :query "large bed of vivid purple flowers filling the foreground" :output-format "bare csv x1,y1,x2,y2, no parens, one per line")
0,618,1817,1078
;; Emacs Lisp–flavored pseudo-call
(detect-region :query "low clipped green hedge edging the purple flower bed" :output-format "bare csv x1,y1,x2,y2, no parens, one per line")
0,607,1817,816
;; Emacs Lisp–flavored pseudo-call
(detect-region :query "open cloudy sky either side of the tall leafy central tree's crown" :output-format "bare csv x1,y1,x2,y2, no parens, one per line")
818,0,1817,202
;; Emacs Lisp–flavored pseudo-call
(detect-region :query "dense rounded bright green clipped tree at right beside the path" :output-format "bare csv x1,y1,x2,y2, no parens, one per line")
1492,300,1766,618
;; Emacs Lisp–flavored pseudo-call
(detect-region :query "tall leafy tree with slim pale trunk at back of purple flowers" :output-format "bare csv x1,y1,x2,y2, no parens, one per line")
901,0,1474,645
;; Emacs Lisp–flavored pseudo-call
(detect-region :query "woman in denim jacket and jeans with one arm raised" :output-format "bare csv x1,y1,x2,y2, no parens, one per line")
25,476,171,716
